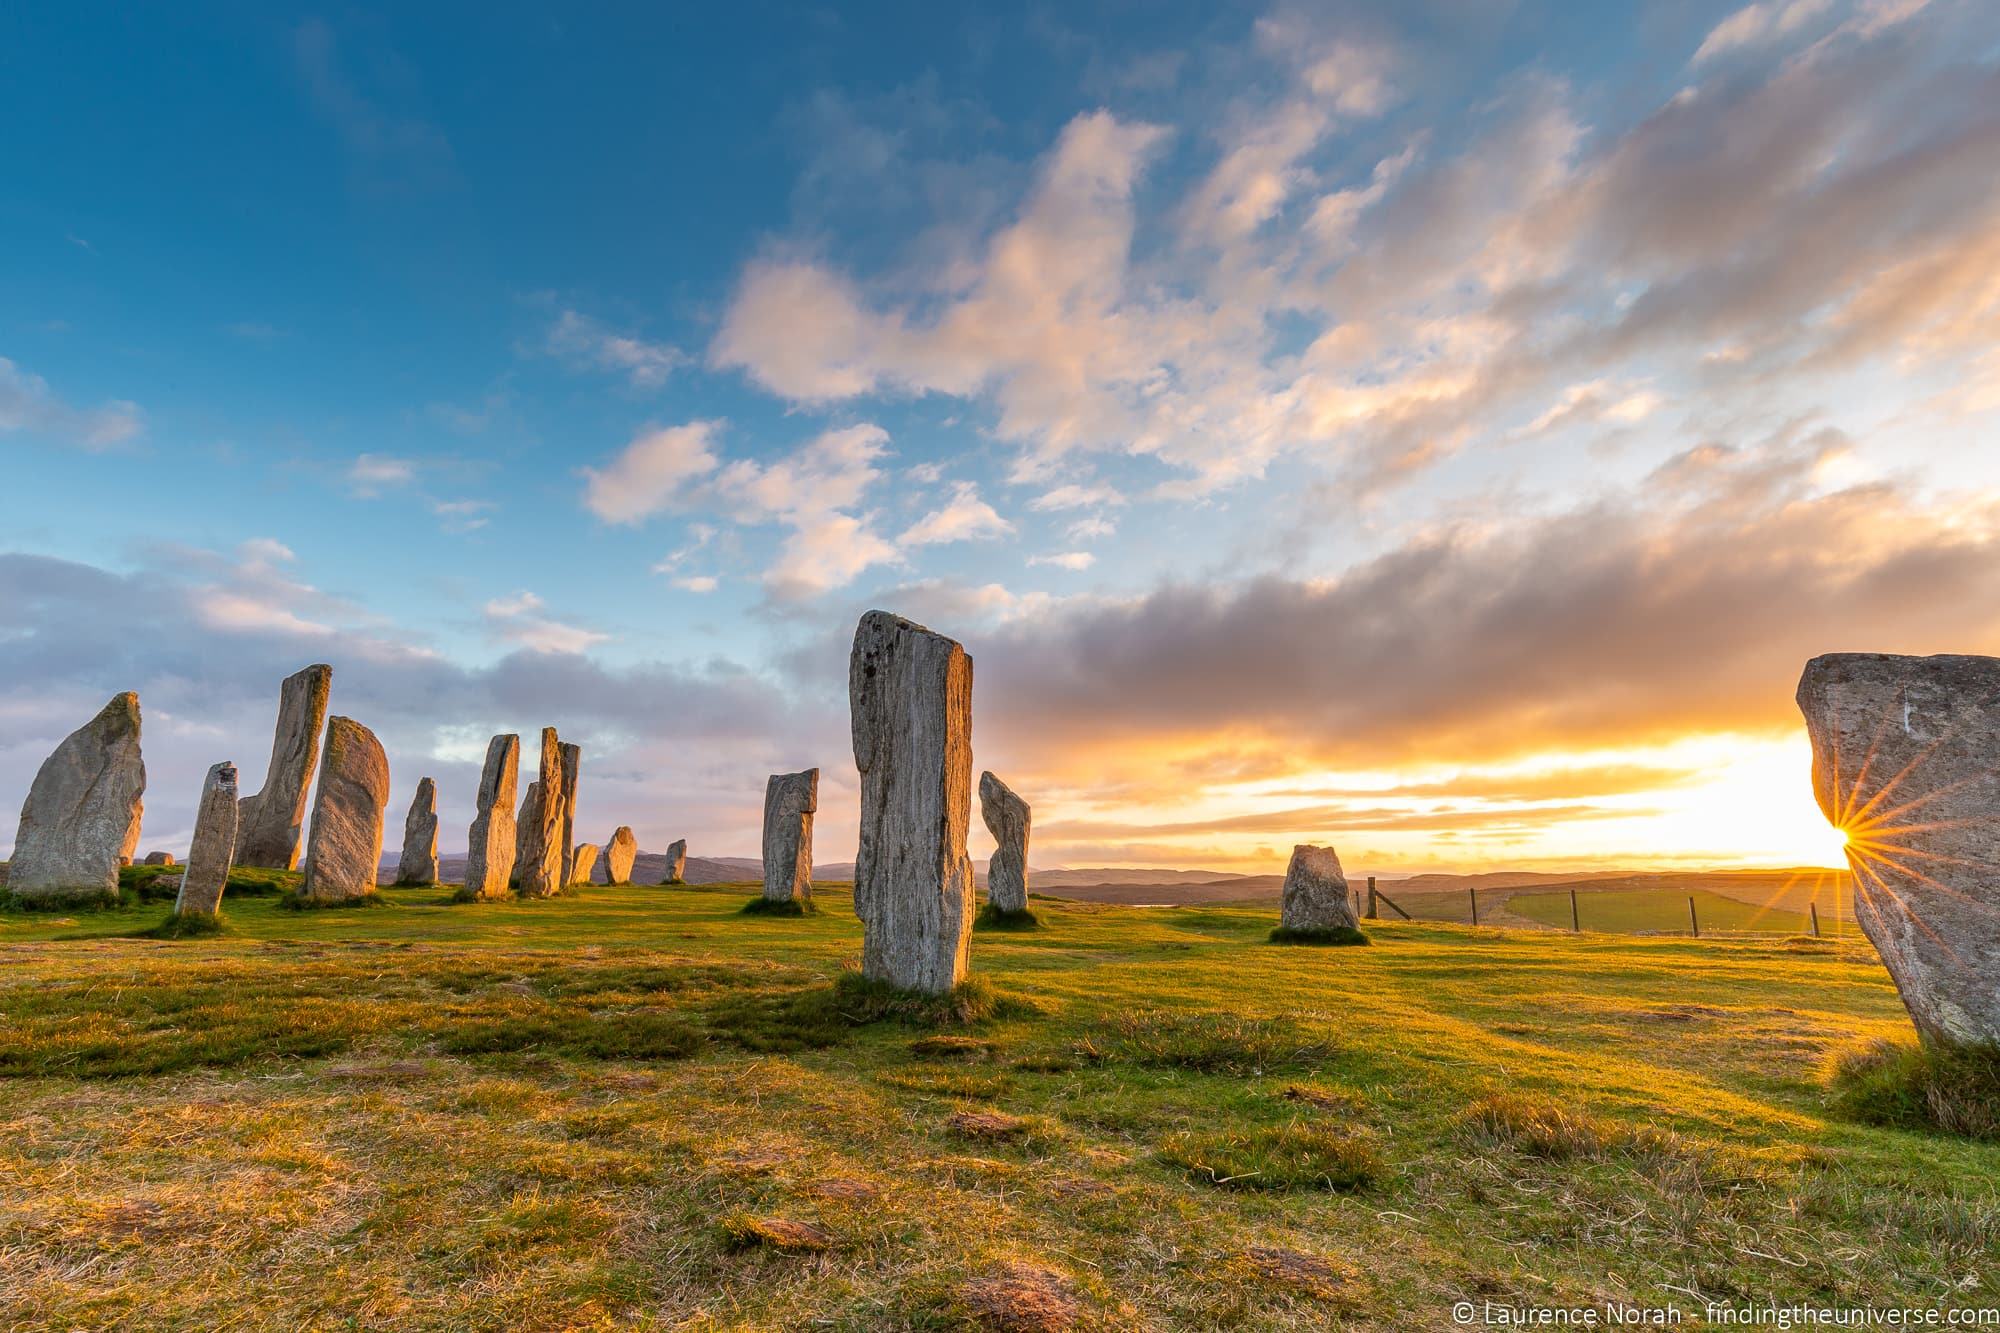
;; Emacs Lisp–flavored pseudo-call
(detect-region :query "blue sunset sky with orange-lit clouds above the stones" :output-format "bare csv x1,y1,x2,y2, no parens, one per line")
0,0,2000,875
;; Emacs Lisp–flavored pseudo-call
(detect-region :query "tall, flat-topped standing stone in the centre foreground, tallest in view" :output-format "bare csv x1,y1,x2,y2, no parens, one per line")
848,610,972,995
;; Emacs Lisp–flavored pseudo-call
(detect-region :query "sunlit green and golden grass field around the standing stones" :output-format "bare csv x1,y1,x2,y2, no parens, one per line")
0,885,2000,1331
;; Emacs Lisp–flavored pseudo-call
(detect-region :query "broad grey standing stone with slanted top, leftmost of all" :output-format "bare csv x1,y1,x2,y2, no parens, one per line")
8,693,146,903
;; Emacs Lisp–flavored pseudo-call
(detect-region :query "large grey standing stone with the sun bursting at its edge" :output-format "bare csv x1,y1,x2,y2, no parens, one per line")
1798,652,2000,1043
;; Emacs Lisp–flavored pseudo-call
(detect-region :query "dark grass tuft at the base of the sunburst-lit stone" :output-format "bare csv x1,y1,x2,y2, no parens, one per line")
1834,1041,2000,1143
